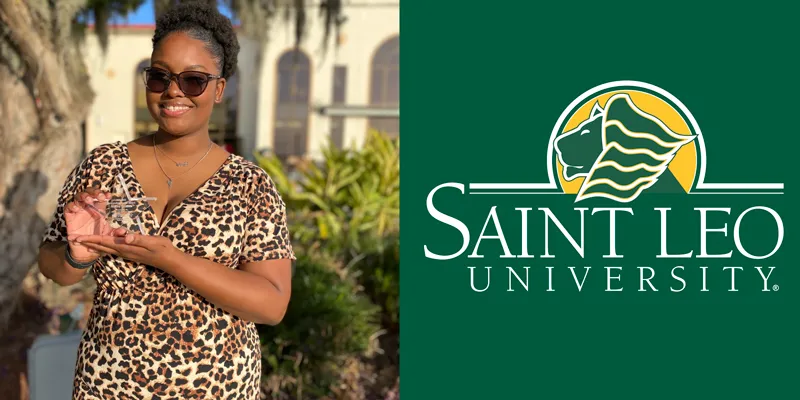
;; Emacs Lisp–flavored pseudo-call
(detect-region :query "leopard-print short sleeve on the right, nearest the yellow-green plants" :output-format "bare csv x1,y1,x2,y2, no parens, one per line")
239,168,296,264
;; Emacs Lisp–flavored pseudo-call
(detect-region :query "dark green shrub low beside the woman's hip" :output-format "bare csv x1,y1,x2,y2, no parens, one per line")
259,254,380,399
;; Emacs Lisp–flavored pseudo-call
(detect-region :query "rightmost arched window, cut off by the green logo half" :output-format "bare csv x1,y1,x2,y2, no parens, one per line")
369,36,400,137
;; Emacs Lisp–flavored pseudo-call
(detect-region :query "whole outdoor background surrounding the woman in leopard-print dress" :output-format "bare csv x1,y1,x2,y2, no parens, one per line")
0,0,400,400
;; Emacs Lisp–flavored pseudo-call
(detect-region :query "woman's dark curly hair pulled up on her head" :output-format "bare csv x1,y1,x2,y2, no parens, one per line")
153,1,239,79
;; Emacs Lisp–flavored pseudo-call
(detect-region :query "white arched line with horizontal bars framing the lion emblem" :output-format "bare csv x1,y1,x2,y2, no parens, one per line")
469,80,784,194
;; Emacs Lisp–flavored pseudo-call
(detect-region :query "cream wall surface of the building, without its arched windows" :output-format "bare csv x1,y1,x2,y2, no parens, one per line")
85,0,400,158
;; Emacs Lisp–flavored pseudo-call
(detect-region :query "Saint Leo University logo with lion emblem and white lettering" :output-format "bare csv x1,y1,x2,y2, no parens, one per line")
424,81,784,292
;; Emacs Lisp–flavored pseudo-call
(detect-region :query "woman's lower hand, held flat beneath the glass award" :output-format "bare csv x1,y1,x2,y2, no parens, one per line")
76,232,183,269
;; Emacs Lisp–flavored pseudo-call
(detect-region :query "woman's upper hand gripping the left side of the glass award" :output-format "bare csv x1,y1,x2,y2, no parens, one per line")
64,188,114,262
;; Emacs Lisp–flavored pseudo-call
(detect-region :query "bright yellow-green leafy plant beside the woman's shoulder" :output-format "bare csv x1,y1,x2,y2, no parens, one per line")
256,131,400,258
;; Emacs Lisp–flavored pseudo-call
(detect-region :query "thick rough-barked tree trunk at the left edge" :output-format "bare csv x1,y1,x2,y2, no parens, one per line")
0,0,93,330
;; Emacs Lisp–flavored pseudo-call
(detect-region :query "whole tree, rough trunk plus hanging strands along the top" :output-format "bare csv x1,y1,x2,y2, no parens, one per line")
0,0,342,337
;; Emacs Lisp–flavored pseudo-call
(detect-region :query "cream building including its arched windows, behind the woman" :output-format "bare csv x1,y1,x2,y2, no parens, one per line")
79,0,400,159
